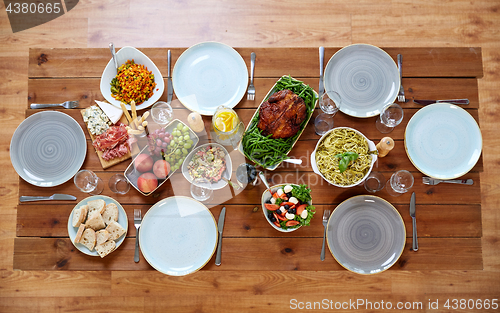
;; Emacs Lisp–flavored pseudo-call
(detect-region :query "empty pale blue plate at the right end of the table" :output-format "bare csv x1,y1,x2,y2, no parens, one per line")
405,103,482,179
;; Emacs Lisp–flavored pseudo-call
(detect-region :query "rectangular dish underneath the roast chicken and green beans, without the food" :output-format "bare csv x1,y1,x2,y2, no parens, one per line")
238,75,318,171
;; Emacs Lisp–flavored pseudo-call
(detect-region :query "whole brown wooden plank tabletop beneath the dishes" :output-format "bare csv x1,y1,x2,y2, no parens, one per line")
14,48,483,272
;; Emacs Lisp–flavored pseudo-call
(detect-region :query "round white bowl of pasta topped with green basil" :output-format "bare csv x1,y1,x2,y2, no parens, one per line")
311,127,377,188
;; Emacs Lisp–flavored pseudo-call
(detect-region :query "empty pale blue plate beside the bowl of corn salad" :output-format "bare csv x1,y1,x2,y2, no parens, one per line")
172,42,248,115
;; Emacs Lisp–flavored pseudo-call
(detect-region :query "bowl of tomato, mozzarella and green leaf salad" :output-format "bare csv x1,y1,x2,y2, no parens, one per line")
262,184,316,232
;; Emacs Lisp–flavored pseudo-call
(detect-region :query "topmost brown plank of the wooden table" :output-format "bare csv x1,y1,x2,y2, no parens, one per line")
28,47,483,78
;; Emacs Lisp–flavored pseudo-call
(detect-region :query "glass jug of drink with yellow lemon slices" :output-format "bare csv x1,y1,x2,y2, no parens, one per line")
212,106,245,150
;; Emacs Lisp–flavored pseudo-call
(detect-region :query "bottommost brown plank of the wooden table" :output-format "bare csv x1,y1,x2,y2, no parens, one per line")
10,237,482,271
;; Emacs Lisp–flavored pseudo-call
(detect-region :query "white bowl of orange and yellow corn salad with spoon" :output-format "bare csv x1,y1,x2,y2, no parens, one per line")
100,47,165,110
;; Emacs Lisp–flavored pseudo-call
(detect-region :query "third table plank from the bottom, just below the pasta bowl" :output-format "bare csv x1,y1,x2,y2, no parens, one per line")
19,171,481,207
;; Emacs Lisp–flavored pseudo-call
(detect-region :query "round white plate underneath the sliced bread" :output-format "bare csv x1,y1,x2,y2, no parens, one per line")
68,195,128,256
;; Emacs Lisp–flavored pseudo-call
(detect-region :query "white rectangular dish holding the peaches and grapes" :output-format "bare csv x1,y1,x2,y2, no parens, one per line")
124,119,200,196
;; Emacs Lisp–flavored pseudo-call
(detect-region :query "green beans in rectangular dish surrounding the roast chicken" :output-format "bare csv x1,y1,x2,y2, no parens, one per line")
238,75,318,171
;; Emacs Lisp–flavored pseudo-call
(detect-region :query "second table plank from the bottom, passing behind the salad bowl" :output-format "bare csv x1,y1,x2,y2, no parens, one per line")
16,204,482,238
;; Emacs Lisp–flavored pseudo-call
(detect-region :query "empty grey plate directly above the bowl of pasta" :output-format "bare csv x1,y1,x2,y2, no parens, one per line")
324,44,400,117
